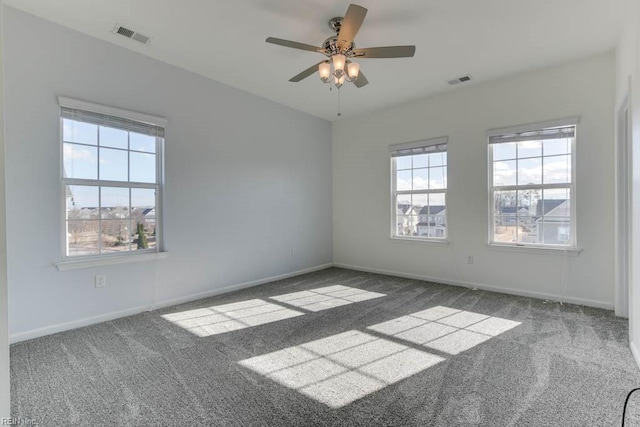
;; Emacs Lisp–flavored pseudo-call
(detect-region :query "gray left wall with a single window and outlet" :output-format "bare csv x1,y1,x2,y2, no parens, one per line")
5,7,332,341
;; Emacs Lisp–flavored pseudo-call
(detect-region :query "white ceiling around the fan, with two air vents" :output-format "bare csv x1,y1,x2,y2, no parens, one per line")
5,0,624,120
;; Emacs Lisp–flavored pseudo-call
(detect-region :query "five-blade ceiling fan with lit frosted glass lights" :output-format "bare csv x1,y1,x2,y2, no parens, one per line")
266,4,416,88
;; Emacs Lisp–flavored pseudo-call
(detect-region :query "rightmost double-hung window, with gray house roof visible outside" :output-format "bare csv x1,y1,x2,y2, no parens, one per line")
488,118,578,248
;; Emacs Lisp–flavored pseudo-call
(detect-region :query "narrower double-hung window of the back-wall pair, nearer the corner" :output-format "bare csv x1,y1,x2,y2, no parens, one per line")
390,137,447,240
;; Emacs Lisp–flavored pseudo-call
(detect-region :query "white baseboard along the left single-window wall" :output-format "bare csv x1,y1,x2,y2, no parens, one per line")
9,263,333,344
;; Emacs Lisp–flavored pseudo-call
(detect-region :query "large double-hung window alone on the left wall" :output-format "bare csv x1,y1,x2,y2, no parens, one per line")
59,97,166,258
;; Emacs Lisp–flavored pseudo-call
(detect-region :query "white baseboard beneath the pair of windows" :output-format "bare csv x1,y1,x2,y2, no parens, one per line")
333,263,613,310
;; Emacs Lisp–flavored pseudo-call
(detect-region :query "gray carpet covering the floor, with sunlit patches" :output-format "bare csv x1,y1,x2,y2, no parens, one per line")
11,268,640,426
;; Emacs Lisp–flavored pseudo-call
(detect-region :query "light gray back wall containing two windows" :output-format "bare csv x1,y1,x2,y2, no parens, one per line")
333,52,615,308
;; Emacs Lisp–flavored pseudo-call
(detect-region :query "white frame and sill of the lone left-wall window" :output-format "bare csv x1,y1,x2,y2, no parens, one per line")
56,96,167,271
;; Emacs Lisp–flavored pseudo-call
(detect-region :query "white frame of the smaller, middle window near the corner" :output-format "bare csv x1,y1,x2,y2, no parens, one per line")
389,136,449,244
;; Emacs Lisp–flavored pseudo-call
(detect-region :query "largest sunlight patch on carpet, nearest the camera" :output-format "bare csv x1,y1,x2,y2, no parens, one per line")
239,330,444,408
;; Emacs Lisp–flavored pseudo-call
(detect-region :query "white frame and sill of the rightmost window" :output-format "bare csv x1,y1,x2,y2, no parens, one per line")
487,117,581,251
